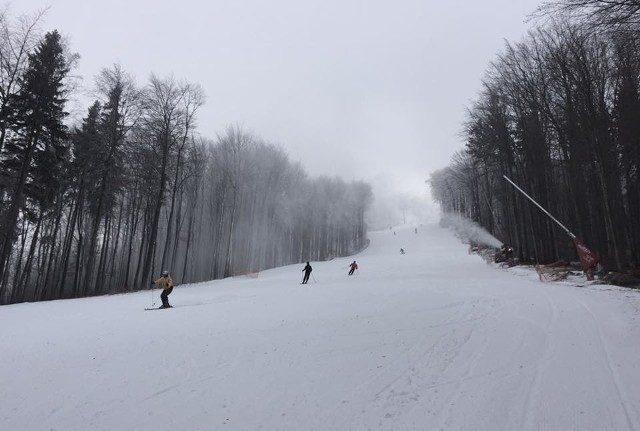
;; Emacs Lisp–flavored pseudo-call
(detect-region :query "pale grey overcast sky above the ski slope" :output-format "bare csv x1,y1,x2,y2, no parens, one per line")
11,0,540,199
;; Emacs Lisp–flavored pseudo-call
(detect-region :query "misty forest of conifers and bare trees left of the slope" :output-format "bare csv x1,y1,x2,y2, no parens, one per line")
0,13,372,304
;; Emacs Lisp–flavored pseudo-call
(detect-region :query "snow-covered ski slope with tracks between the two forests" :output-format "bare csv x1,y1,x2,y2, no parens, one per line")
0,225,640,431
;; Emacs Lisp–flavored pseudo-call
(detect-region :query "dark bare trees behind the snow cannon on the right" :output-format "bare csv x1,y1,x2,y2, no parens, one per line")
430,1,640,270
